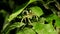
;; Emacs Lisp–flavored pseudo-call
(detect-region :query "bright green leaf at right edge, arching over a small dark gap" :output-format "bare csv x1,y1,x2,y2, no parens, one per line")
46,14,60,28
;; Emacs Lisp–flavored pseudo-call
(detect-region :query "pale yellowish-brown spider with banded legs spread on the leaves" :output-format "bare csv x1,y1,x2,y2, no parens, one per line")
21,10,38,24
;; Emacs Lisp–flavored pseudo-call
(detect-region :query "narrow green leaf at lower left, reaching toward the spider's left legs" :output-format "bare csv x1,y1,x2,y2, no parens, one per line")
3,22,25,34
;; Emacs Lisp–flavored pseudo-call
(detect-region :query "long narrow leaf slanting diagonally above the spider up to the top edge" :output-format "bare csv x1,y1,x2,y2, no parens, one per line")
3,0,37,33
